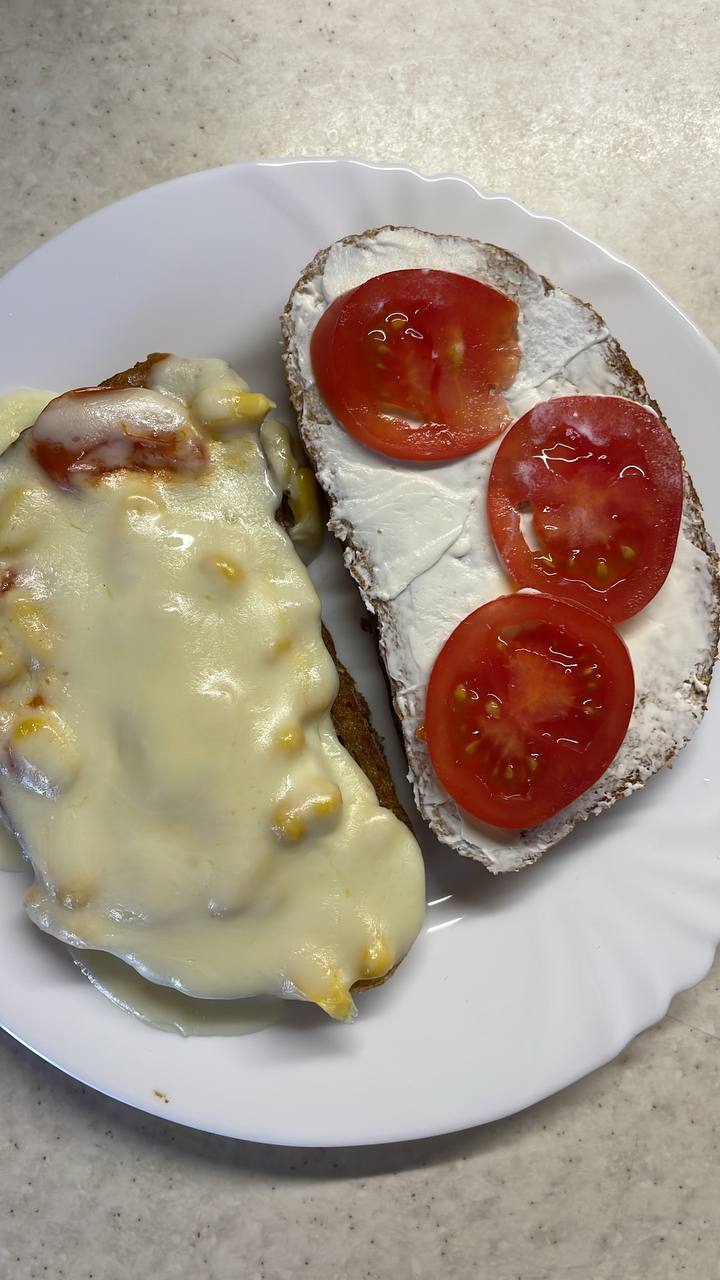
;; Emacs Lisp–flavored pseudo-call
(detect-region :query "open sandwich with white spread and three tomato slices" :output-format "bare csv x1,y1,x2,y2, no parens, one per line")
282,227,720,872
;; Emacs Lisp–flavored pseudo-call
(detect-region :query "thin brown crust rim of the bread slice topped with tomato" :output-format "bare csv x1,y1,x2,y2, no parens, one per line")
281,224,720,872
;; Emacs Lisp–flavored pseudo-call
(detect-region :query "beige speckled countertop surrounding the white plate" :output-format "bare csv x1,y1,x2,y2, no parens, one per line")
0,0,720,1280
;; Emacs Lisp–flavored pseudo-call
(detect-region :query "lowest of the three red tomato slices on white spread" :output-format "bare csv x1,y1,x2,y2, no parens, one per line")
425,593,634,831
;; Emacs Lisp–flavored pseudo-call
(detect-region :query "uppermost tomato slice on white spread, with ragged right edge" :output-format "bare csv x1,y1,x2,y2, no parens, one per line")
310,270,520,461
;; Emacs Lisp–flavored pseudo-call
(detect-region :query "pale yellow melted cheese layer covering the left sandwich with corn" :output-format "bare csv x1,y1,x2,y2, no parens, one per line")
0,358,424,1018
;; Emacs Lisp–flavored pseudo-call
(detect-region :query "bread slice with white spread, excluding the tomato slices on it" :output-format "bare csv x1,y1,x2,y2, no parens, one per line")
281,227,720,872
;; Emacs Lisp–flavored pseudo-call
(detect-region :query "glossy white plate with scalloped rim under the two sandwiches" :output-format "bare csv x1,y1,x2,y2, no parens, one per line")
0,160,720,1146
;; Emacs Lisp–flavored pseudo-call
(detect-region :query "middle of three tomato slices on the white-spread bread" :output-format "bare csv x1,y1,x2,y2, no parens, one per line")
488,396,683,622
